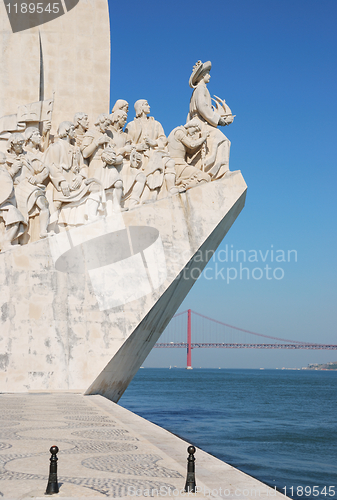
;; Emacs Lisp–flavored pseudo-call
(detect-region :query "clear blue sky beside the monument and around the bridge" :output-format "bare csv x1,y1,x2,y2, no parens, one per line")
110,0,337,368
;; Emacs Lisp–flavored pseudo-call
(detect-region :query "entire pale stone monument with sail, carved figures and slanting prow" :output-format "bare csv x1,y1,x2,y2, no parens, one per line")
0,0,246,401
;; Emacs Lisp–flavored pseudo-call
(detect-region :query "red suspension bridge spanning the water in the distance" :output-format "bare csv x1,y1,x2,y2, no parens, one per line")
154,309,337,368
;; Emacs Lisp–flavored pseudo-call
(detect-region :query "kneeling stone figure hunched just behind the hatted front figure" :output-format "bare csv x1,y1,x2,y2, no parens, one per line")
168,119,211,190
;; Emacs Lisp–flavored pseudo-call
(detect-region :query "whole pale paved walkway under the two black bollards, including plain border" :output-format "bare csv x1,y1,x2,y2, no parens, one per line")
0,393,285,500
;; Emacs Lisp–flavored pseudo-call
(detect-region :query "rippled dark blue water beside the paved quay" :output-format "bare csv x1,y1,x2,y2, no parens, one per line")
120,368,337,500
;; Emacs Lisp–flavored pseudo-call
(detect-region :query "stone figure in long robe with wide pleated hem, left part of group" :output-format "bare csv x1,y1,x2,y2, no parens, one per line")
45,122,105,226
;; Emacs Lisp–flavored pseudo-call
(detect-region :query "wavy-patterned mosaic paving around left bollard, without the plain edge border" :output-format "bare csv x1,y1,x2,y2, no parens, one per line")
0,393,185,498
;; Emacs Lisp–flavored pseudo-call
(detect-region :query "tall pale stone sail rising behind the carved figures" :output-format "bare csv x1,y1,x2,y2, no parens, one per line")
0,0,110,140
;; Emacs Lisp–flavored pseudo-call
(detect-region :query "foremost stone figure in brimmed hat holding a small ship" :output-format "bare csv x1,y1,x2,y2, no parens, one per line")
187,61,234,180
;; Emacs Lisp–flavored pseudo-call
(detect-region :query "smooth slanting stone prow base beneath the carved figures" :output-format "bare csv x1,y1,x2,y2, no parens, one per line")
0,172,246,401
